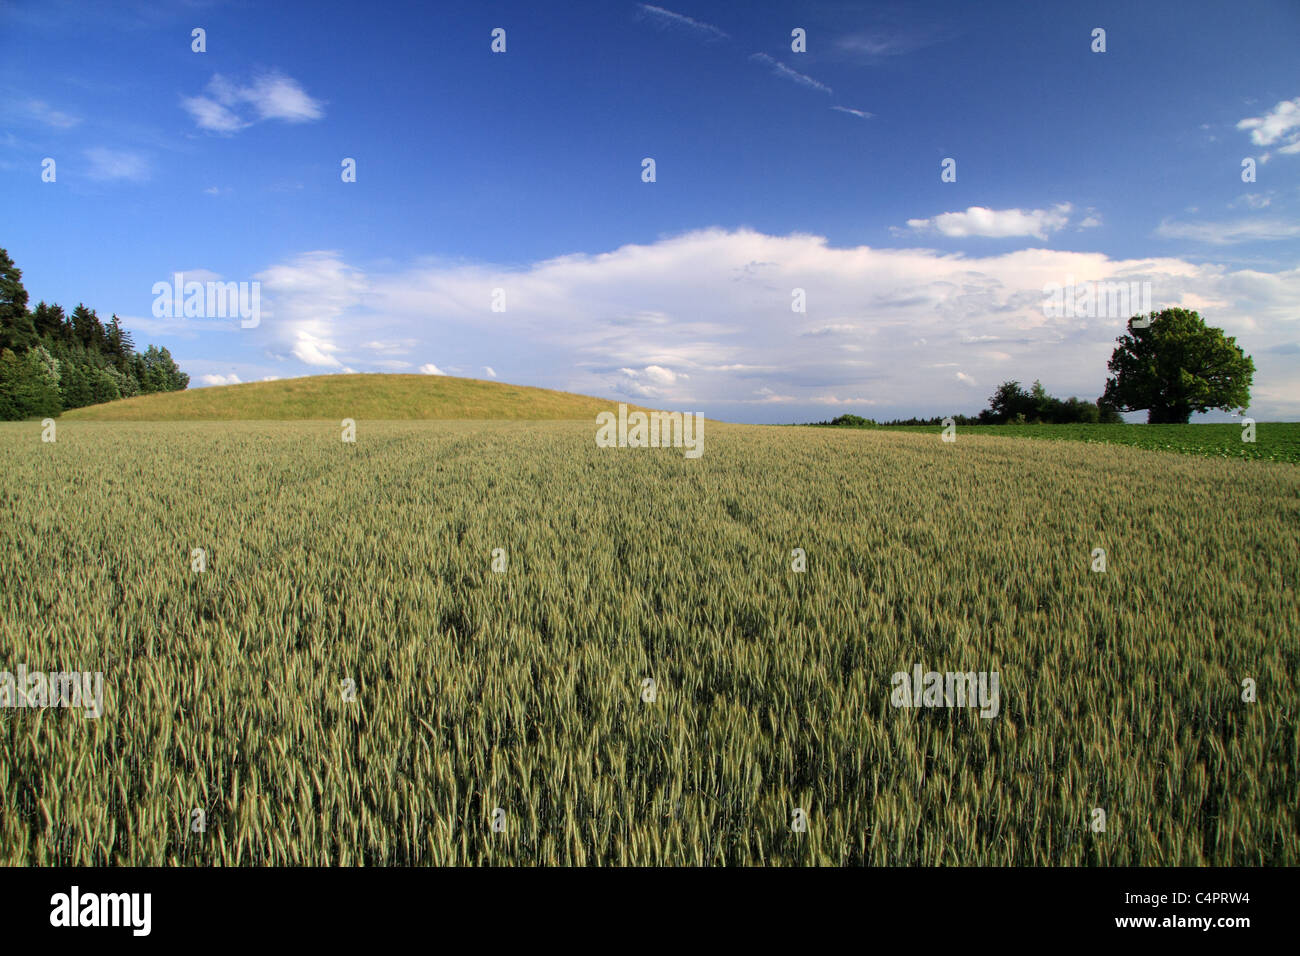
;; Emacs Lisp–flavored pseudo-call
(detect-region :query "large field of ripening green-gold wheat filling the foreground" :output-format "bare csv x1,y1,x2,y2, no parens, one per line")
0,420,1300,865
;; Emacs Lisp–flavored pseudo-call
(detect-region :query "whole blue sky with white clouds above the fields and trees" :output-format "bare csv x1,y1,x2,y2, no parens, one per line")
0,0,1300,421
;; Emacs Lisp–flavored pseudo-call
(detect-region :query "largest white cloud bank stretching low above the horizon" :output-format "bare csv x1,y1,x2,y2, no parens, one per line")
231,229,1300,421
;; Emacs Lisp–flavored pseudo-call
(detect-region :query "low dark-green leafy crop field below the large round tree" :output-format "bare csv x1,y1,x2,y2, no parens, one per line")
842,421,1300,464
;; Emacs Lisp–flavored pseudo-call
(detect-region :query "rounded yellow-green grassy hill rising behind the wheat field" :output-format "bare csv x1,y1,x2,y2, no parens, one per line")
62,375,650,421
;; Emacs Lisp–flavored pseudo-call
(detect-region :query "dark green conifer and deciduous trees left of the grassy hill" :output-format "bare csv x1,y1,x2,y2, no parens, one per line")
0,248,190,421
